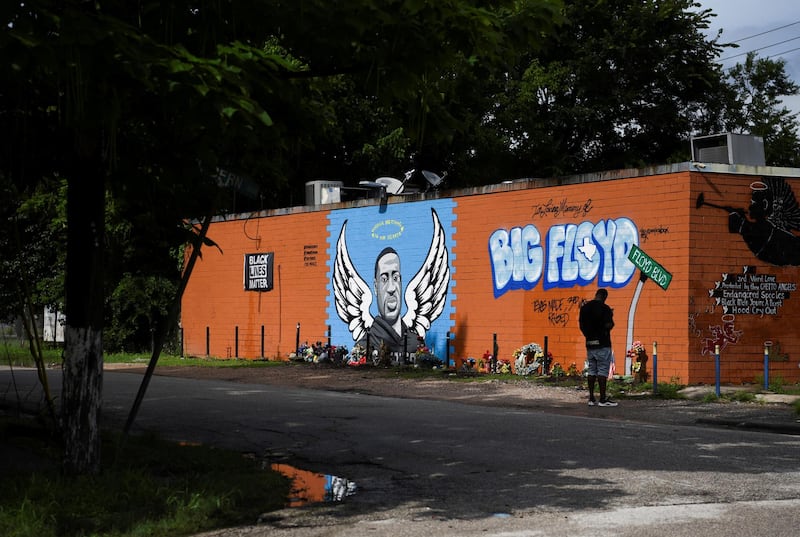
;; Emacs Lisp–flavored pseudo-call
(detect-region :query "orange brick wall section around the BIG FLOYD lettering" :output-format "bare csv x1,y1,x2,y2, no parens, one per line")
455,174,690,380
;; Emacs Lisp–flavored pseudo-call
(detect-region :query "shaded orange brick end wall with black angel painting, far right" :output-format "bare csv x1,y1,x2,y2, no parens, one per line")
688,173,800,383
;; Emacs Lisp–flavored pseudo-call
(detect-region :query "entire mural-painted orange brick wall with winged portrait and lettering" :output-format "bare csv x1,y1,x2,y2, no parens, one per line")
181,163,800,384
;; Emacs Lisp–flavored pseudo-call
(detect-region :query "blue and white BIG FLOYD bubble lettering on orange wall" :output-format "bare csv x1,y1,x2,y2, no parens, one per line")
489,218,639,297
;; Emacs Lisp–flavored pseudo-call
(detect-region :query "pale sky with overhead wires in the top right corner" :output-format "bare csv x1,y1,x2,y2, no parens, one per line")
697,0,800,118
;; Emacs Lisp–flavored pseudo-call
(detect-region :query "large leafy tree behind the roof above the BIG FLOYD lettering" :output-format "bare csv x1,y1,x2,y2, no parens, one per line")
294,0,725,187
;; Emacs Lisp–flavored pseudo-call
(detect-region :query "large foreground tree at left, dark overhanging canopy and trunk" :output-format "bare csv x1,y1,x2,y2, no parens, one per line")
0,0,558,473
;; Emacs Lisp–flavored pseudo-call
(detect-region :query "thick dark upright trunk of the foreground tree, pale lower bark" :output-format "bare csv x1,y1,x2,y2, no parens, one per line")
61,158,105,474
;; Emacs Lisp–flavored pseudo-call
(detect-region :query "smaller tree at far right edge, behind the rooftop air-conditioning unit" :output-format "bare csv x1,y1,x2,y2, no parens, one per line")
722,52,800,168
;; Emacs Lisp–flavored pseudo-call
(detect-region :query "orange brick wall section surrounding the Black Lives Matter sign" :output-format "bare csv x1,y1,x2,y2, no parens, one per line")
181,212,328,359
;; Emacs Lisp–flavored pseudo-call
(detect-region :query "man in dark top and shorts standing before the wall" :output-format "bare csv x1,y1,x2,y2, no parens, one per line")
578,289,617,406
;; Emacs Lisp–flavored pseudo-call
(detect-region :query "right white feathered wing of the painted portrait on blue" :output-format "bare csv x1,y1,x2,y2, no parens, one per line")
403,209,450,337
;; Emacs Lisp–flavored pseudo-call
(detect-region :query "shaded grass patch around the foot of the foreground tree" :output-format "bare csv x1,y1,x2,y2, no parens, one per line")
0,417,290,537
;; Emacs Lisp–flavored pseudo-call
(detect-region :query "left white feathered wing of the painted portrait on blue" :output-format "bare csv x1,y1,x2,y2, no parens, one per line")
333,221,373,341
